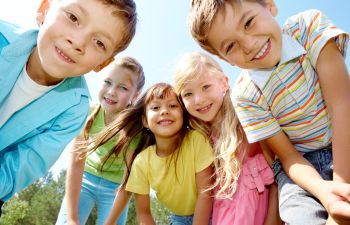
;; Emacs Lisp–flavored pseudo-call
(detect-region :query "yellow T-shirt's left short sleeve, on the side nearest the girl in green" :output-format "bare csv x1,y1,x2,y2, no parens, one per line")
126,154,150,195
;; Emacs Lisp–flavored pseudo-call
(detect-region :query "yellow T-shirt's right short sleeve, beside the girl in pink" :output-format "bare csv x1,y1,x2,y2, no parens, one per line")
190,131,214,173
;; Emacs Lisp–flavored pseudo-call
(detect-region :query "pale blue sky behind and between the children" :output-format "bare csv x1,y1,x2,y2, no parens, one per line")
0,0,350,173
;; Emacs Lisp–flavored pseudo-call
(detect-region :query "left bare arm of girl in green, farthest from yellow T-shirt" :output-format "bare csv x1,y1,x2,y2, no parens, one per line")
66,138,85,225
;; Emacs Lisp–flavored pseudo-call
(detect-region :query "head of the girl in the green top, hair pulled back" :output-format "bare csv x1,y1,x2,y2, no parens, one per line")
98,57,145,114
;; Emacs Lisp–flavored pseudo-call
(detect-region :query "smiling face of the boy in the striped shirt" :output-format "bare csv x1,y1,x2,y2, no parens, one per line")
208,0,282,69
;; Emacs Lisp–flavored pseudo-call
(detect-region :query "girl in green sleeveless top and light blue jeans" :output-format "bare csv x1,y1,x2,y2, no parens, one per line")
56,57,145,225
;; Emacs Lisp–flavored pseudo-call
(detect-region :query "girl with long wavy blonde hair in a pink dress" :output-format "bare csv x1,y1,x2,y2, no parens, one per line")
175,52,278,225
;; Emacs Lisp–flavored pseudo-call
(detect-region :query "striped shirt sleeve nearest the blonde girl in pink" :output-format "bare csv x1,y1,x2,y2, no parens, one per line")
231,76,281,143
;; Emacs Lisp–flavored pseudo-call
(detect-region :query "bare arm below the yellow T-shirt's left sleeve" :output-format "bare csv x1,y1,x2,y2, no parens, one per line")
134,194,156,225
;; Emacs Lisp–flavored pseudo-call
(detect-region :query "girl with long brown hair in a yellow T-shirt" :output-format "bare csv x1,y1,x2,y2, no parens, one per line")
90,83,213,225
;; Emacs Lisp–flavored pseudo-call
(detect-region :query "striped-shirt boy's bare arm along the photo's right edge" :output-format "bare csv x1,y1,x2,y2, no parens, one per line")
316,39,350,183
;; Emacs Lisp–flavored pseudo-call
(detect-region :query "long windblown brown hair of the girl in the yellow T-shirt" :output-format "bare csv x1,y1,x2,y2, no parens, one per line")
90,83,188,187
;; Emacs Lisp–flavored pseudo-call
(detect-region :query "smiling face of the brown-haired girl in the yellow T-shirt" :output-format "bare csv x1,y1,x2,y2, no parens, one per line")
144,92,184,140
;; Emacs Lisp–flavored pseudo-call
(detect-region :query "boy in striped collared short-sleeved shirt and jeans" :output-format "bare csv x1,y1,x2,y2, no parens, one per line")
189,0,350,224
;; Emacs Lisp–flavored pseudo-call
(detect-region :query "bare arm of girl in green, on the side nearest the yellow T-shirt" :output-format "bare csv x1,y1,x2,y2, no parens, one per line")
104,188,131,225
